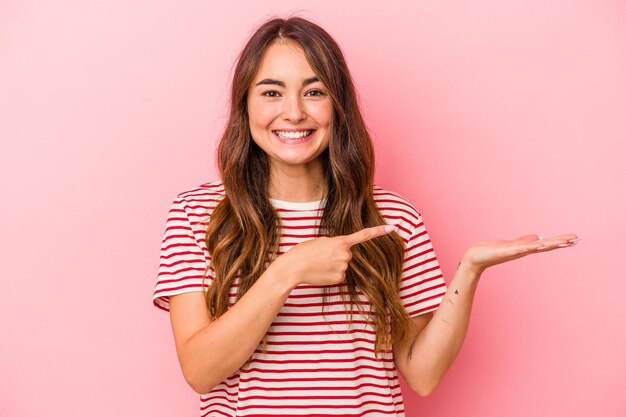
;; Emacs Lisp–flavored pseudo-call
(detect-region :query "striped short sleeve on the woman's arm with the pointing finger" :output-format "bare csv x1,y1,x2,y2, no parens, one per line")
152,197,212,311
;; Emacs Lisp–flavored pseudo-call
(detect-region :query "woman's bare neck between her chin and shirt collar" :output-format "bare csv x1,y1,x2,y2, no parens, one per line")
268,159,326,203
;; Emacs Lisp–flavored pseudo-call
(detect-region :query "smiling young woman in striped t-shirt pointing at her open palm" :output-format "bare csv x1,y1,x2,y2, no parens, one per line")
153,17,577,416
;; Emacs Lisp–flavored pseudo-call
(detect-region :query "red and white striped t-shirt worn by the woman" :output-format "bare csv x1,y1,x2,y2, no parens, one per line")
153,180,446,417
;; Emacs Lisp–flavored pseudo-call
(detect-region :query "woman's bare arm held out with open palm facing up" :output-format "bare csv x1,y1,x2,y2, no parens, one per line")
394,235,578,396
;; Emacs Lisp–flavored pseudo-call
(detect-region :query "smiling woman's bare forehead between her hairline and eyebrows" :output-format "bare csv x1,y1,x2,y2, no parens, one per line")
254,40,316,81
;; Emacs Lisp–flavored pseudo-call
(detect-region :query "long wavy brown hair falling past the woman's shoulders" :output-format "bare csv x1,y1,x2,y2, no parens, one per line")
206,17,411,356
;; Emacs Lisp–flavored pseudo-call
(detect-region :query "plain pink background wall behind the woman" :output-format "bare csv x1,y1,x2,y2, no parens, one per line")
0,0,626,417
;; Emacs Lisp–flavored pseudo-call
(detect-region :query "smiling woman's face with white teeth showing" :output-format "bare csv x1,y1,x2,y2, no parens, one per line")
247,41,333,169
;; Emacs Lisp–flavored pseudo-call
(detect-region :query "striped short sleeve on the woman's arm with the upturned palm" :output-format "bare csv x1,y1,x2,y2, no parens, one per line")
400,215,447,317
